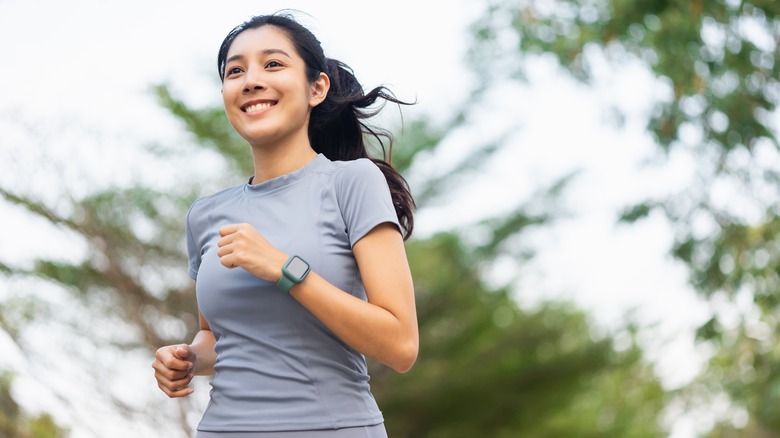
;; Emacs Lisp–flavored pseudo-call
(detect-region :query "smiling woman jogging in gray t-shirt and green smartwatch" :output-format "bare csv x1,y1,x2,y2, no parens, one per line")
152,15,418,438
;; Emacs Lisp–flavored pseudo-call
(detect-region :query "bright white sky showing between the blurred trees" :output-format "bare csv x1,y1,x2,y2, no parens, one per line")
0,0,720,438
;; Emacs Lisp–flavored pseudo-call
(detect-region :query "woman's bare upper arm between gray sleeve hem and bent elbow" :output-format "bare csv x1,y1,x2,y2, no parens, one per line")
352,222,417,329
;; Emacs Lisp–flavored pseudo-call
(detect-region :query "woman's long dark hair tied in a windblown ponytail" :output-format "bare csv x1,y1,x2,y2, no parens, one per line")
217,14,415,239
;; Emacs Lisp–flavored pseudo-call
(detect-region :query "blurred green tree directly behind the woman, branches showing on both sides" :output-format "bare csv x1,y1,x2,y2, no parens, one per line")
158,87,666,437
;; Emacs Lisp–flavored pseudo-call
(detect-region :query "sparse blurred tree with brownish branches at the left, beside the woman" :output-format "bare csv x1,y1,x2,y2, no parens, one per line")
0,123,207,436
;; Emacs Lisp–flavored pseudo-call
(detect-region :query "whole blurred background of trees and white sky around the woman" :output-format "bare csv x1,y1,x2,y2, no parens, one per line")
0,0,780,438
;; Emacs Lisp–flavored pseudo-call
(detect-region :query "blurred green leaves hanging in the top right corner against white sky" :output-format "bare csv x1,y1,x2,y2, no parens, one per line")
474,0,780,153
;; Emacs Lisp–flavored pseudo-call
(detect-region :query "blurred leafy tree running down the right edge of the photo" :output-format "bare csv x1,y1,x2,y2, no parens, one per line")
472,0,780,437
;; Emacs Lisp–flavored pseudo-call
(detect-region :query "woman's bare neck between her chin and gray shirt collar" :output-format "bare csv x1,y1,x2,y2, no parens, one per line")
247,132,317,184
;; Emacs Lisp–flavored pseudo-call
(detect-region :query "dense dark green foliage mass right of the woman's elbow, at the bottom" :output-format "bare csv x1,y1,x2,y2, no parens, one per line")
372,231,664,437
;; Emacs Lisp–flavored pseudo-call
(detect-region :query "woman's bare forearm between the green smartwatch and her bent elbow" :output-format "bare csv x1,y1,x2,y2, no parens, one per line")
290,272,419,372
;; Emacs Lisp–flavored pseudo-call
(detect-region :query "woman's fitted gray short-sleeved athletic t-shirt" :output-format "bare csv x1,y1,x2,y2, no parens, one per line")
187,155,398,432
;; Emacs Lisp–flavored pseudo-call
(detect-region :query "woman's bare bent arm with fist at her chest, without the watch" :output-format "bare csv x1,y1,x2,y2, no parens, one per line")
219,222,419,372
